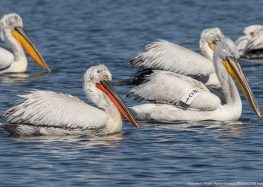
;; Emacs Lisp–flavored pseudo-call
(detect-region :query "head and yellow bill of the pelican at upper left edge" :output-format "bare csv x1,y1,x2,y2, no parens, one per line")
0,13,51,72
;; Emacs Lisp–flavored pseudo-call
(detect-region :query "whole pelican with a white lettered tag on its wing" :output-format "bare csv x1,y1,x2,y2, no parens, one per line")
128,38,261,121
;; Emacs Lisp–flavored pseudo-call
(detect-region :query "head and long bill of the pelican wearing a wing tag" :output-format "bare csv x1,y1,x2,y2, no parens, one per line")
217,38,261,118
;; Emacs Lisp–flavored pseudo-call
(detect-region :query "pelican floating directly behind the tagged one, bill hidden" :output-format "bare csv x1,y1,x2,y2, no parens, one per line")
130,28,224,87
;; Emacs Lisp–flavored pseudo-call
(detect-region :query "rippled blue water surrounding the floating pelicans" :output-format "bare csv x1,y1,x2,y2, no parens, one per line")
0,0,263,186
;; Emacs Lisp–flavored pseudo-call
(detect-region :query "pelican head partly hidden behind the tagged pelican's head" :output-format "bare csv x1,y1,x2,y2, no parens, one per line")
199,27,224,60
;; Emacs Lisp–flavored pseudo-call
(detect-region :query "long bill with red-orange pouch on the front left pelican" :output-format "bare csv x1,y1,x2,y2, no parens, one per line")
96,81,140,128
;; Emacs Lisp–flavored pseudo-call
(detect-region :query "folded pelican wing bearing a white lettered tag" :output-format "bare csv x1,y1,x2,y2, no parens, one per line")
128,70,221,110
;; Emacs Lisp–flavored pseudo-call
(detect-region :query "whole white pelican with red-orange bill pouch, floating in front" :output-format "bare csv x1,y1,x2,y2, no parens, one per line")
0,65,139,136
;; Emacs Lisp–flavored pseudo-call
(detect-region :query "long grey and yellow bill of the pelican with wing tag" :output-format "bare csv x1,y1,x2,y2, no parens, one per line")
223,57,261,118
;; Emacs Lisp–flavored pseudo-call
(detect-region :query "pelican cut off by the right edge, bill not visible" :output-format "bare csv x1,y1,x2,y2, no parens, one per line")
235,25,263,60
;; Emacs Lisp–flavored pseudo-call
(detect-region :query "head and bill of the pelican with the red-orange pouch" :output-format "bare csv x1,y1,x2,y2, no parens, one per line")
84,64,139,128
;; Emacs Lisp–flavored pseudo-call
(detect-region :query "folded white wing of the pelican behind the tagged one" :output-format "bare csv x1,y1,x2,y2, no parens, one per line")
130,40,214,75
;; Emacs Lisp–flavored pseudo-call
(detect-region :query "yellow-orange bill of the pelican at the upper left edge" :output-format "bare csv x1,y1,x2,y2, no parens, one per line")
12,27,51,73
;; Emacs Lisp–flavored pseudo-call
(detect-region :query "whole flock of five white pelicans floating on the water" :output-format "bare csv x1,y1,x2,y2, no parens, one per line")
0,13,263,135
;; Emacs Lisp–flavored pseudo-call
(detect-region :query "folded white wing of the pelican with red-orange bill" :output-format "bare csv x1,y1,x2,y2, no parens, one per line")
4,90,108,130
